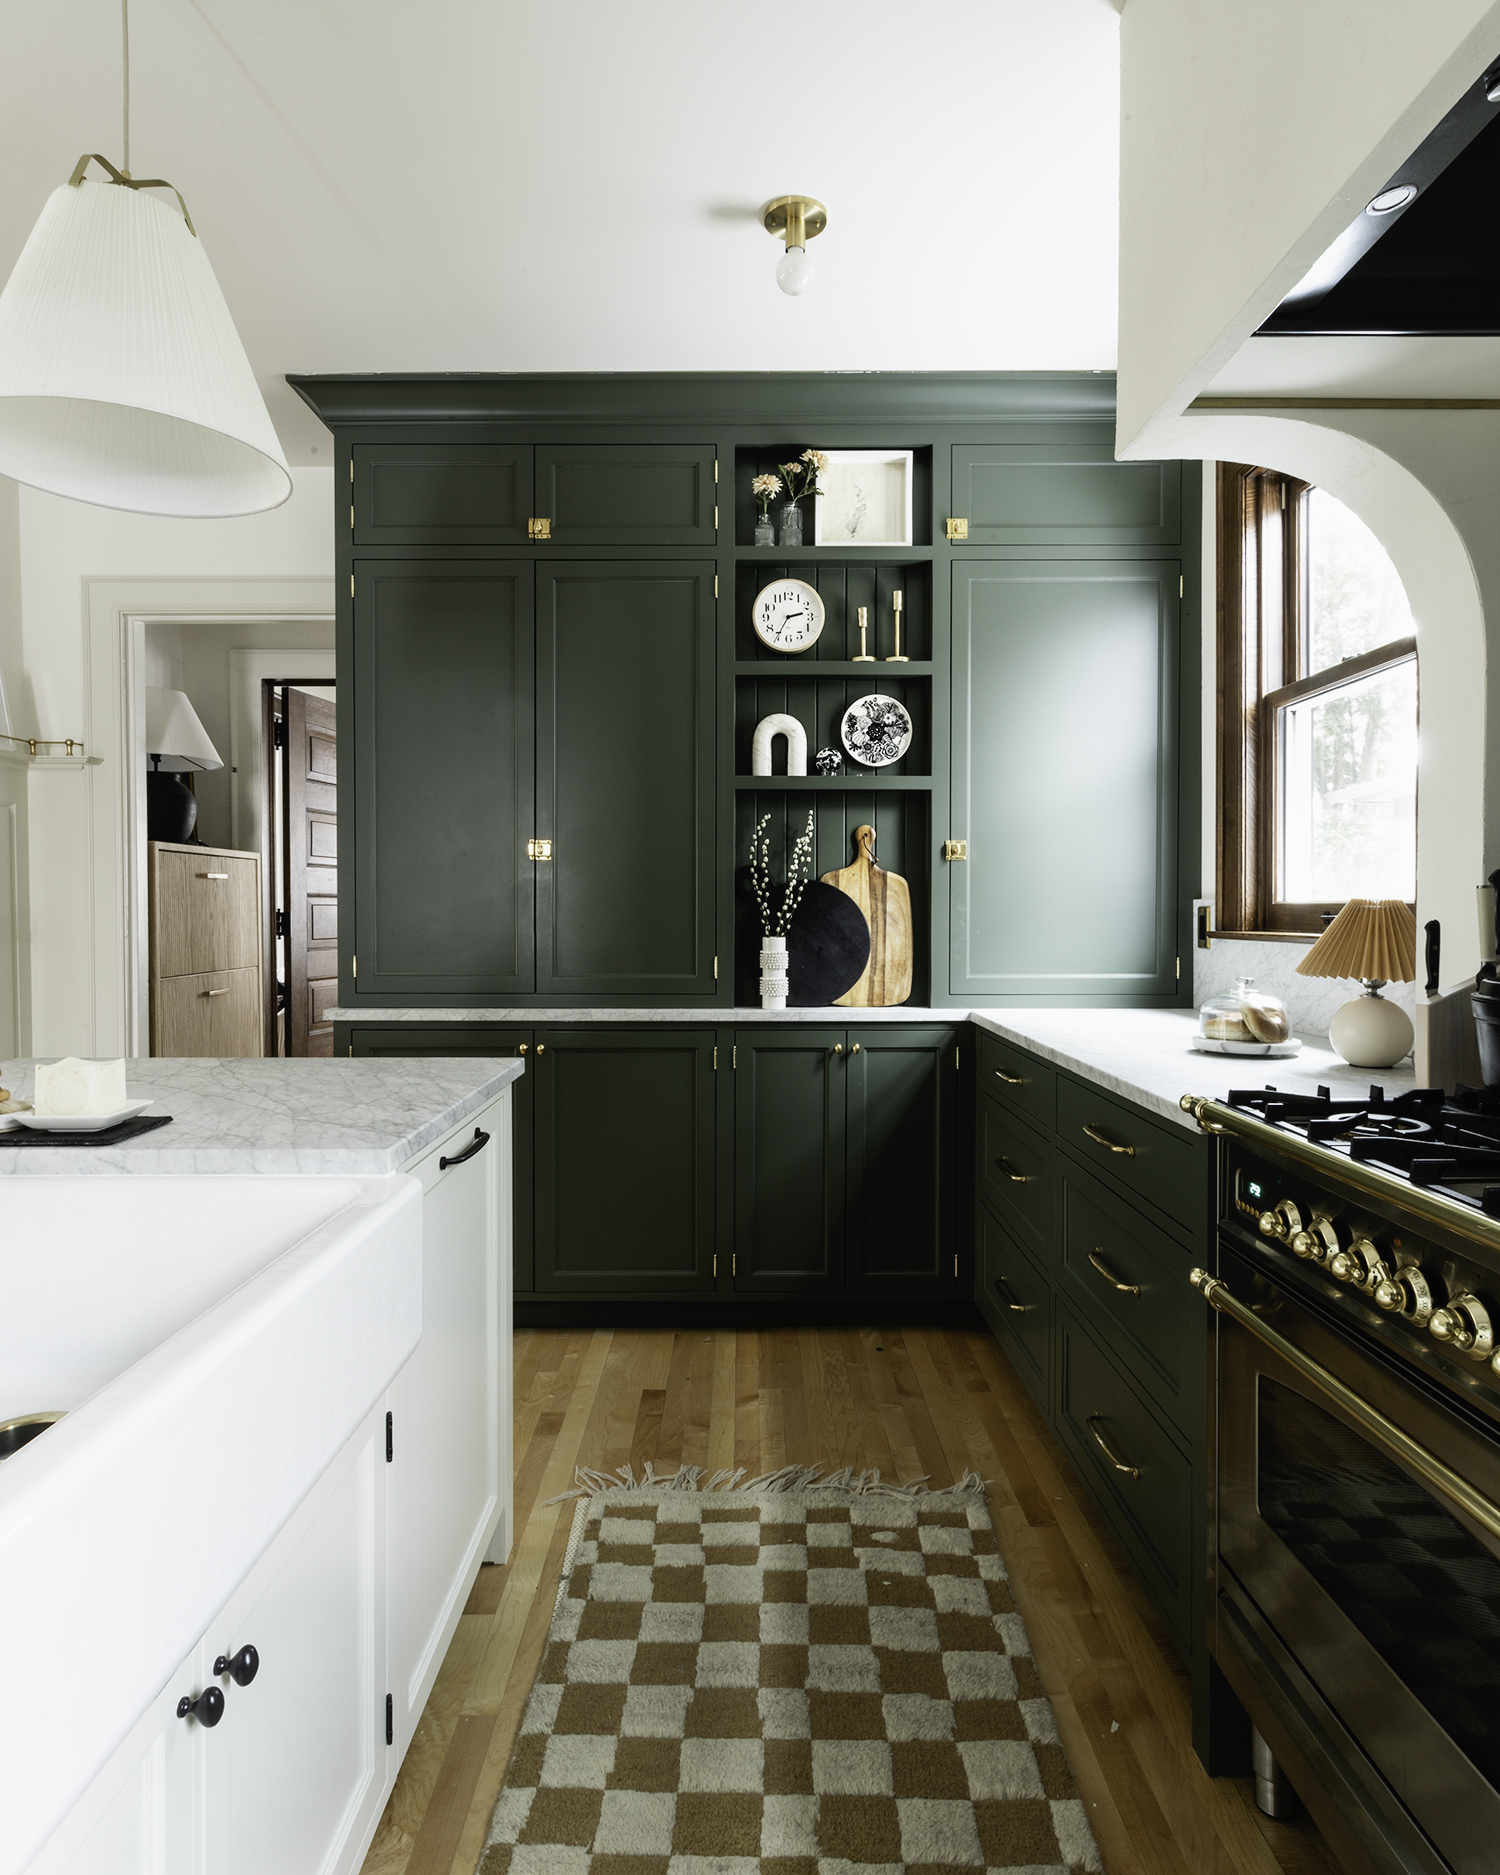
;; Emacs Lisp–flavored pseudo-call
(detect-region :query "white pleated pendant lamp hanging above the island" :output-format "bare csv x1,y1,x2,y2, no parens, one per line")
0,3,293,518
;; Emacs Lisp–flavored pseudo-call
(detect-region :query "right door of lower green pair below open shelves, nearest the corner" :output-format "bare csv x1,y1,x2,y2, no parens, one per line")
844,1026,960,1296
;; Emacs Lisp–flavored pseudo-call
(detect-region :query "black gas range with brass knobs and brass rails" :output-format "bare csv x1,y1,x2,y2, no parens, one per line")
1181,1086,1500,1875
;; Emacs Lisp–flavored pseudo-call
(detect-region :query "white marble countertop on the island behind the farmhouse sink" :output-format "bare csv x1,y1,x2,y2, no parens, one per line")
0,1058,525,1176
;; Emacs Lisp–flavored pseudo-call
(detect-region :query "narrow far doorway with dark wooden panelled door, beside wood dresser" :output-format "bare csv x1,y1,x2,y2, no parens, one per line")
271,679,339,1056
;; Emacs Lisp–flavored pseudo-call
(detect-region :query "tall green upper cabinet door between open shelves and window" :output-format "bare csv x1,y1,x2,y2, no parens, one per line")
947,561,1179,999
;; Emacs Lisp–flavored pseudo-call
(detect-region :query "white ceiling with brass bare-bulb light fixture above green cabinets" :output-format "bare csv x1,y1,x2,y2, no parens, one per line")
0,0,1119,461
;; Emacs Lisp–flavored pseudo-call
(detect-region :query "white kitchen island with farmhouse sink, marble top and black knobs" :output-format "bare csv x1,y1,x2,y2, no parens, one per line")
0,1059,521,1875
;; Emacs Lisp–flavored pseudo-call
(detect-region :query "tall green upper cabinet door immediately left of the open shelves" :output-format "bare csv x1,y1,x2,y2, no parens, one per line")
534,561,714,1003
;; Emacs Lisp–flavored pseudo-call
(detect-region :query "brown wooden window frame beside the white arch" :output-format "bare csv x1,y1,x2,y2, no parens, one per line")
1215,463,1418,941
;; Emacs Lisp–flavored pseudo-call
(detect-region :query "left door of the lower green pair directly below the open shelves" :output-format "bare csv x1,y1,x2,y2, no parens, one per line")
733,1022,849,1294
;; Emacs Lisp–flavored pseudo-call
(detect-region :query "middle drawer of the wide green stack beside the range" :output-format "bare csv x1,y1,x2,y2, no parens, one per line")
1058,1172,1204,1433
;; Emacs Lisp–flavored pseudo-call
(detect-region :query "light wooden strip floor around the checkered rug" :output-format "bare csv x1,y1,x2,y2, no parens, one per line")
366,1328,1337,1875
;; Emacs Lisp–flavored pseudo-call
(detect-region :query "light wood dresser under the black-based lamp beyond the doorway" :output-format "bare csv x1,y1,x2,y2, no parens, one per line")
146,840,266,1056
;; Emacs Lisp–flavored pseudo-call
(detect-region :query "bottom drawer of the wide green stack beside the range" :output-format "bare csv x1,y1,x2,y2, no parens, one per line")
1058,1299,1194,1652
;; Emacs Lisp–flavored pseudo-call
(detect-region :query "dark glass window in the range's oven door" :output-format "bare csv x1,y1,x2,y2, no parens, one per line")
1256,1376,1500,1789
